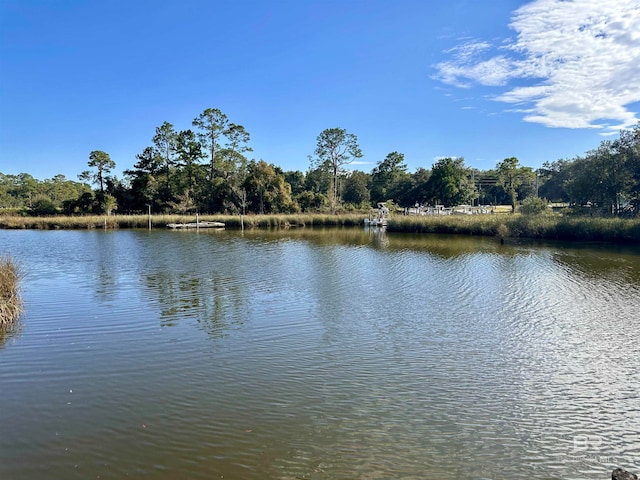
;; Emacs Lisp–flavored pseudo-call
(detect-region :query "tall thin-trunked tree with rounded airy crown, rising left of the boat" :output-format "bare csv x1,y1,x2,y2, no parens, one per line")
313,128,362,209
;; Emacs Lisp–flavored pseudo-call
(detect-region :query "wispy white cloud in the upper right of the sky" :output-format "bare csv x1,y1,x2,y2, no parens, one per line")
436,0,640,134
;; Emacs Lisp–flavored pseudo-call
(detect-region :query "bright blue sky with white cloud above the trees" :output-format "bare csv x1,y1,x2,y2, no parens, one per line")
0,0,640,180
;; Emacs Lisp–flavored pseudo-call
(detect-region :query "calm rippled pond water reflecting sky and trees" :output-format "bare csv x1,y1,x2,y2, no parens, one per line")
0,229,640,480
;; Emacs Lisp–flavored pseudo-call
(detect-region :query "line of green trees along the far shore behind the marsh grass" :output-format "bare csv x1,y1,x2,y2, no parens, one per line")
0,108,640,215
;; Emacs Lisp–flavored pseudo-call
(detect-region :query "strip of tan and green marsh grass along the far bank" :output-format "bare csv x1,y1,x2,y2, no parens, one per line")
0,213,640,243
